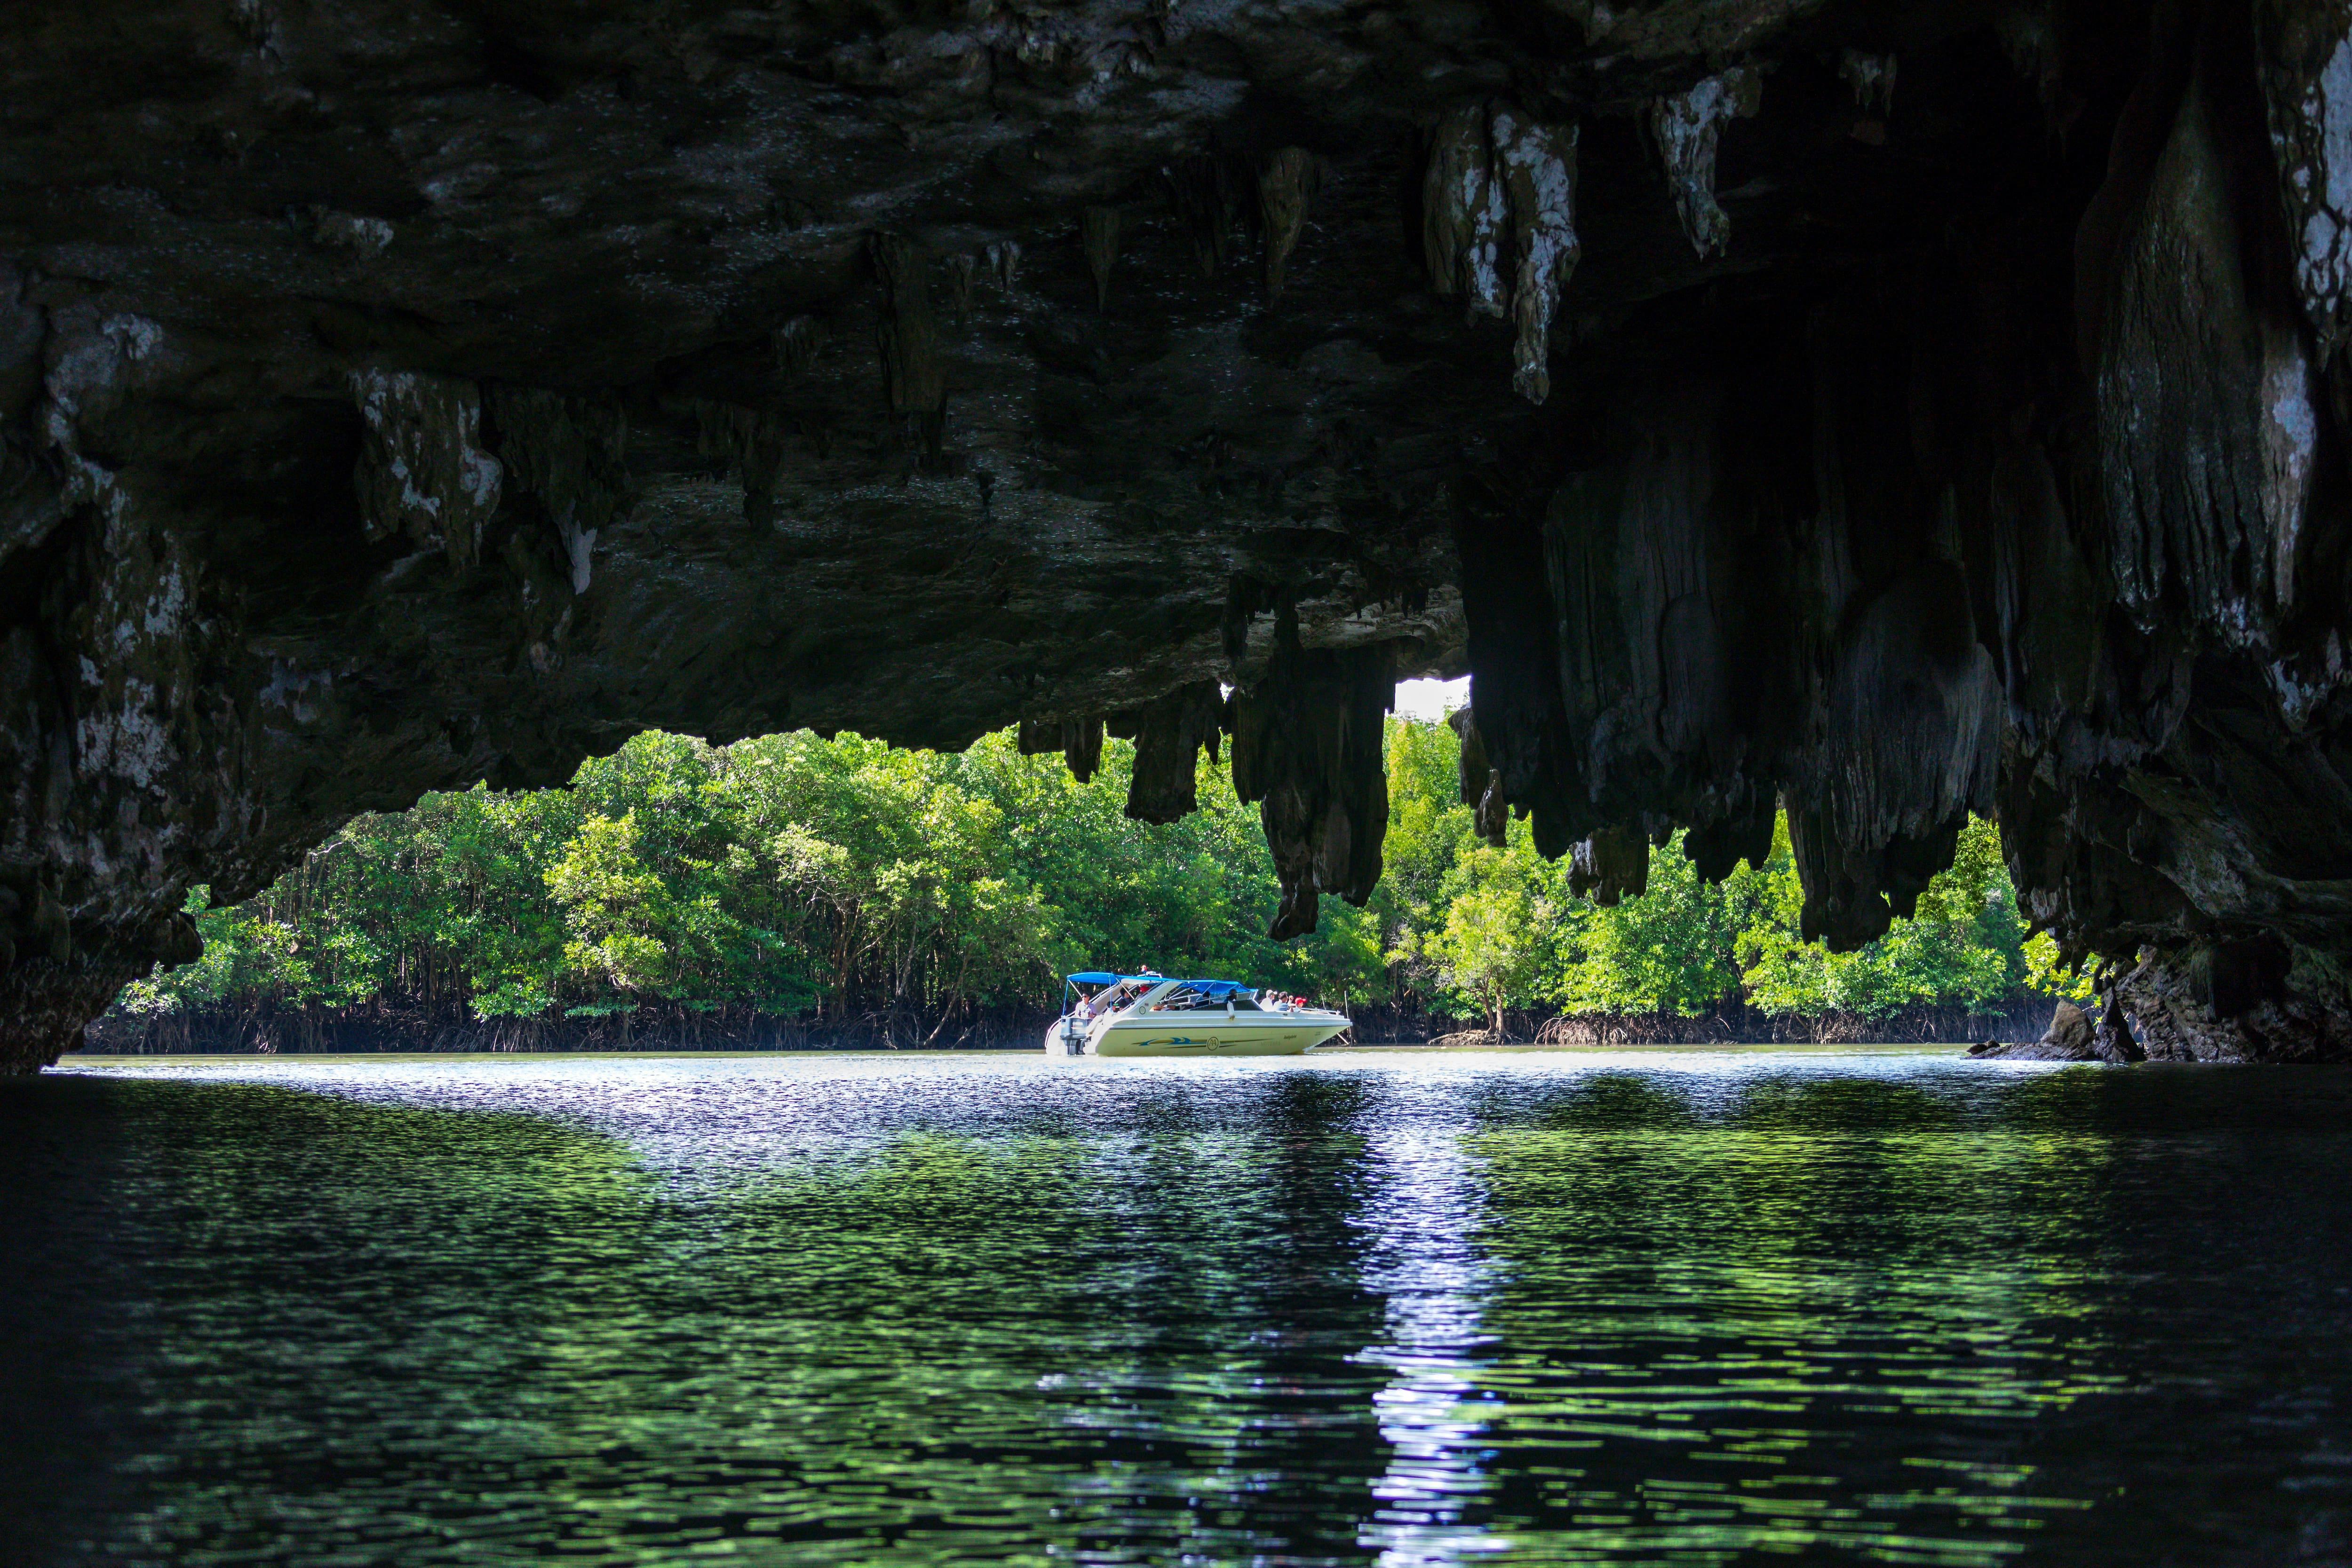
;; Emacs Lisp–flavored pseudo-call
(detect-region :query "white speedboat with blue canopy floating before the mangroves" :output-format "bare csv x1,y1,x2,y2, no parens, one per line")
1044,971,1348,1055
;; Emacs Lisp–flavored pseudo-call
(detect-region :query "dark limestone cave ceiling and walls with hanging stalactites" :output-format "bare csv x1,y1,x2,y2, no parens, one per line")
0,0,2352,1069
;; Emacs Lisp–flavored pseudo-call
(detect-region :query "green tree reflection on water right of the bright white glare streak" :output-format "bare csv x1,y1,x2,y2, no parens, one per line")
1465,1077,2124,1566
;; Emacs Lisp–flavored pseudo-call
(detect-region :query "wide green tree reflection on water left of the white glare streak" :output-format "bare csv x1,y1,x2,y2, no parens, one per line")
23,1084,1378,1563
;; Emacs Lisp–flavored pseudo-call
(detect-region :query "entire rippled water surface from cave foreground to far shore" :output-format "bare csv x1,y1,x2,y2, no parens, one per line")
0,1053,2352,1566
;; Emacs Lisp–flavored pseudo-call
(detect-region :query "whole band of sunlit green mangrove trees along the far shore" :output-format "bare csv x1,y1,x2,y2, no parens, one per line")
85,720,2089,1055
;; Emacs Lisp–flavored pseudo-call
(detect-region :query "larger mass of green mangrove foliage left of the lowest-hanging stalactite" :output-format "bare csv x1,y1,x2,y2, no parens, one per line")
120,731,1385,1020
